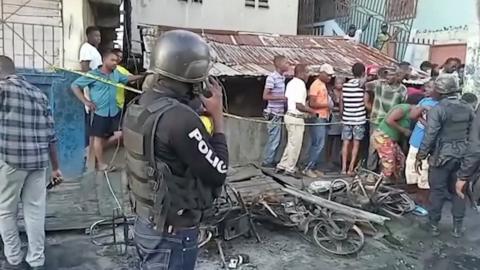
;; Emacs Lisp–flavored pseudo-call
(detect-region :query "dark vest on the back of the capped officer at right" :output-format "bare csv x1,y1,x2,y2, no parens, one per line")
439,101,473,144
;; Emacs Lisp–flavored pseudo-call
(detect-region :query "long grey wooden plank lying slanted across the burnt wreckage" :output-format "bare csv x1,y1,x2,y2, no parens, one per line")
282,187,390,225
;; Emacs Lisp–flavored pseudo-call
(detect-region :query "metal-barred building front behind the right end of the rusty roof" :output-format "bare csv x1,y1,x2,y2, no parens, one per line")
298,0,421,59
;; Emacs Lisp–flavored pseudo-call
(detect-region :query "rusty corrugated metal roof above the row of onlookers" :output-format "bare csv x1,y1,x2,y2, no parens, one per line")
142,27,396,76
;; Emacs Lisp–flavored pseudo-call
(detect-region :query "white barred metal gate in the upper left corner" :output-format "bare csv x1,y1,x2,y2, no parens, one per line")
0,0,64,71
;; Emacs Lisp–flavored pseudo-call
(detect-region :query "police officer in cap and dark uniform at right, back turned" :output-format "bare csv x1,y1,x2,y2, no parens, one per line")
415,74,474,237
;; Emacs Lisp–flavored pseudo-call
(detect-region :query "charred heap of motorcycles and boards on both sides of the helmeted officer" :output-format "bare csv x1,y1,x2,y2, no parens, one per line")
89,165,415,268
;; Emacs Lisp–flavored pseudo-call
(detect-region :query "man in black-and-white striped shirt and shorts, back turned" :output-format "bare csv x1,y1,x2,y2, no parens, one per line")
340,63,367,175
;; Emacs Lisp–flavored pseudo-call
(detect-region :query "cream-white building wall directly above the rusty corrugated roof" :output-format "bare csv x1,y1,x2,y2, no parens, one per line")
132,0,298,51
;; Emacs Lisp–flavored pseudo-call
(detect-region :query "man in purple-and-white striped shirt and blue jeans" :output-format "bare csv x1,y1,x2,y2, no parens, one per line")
262,55,289,168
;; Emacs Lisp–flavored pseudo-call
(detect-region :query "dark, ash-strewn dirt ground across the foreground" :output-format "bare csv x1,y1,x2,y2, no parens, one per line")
10,205,480,270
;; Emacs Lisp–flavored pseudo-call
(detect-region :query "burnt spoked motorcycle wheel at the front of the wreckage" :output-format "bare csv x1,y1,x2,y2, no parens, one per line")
312,220,365,255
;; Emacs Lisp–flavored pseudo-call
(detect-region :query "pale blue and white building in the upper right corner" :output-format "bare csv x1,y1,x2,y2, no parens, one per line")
404,0,480,95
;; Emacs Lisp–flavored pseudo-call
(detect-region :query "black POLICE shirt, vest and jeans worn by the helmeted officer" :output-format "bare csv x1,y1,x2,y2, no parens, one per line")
124,85,228,270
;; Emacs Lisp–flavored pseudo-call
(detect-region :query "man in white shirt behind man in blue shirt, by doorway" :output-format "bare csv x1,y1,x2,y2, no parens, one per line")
80,26,102,72
